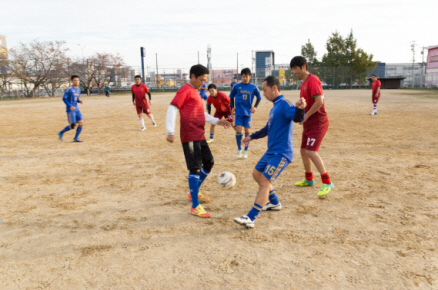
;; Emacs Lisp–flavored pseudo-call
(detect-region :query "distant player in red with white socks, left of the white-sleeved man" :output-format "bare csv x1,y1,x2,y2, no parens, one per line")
131,75,157,131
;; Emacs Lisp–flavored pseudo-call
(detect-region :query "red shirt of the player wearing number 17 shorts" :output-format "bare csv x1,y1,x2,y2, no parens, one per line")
300,74,329,129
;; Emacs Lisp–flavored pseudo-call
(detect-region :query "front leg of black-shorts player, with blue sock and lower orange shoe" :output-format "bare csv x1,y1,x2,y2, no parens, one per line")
182,141,210,217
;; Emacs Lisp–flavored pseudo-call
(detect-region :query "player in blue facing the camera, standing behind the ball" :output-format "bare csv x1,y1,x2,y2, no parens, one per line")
230,68,262,158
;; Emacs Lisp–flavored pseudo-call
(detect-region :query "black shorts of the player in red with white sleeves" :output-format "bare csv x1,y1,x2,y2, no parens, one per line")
183,140,213,170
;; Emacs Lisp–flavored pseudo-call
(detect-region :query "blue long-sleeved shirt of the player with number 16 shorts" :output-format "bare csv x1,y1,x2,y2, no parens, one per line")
250,95,304,162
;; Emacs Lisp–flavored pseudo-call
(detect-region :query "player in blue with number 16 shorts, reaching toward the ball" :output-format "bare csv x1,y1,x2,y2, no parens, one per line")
234,76,306,228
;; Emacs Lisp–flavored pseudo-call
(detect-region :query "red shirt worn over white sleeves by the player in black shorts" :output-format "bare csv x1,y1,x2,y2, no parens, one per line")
170,84,205,143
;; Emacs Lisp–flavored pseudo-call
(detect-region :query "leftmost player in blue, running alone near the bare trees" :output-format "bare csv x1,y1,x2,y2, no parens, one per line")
58,75,84,142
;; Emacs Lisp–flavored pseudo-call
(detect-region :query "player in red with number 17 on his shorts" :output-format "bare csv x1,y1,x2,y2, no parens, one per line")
290,56,334,196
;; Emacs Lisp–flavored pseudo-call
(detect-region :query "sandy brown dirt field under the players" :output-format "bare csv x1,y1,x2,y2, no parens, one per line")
0,90,438,289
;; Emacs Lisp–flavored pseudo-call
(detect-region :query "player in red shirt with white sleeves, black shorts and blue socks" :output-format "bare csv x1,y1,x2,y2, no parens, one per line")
166,64,231,218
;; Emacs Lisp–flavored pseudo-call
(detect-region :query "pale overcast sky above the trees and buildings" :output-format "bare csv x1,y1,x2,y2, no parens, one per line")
0,0,438,69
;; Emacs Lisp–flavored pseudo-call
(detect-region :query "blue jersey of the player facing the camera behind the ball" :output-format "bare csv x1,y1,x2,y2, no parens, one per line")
230,83,262,116
